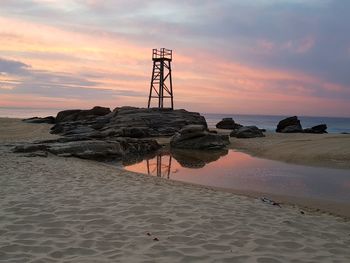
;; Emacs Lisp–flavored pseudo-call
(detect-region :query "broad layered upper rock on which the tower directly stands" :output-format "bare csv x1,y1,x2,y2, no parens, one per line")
51,107,207,138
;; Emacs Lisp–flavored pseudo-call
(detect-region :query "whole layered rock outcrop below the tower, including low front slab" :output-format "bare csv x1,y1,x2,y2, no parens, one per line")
14,106,209,160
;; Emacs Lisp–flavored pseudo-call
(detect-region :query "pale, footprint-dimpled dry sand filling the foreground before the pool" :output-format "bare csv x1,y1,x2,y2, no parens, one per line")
0,119,350,263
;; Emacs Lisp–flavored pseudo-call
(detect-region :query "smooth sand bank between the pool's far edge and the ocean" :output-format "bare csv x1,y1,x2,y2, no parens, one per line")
230,132,350,169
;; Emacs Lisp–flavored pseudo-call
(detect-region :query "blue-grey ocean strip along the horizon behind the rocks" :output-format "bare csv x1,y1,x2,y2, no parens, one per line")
0,107,350,133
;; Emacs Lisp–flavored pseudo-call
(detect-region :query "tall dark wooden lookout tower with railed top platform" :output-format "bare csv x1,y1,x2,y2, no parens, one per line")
148,48,174,109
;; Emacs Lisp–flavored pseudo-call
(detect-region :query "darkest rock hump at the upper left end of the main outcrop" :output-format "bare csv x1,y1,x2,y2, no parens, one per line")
56,106,111,123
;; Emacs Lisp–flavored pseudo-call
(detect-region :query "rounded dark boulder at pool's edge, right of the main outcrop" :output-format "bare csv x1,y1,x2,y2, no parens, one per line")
170,125,230,149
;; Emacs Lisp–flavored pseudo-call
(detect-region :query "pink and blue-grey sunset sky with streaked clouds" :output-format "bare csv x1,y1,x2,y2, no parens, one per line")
0,0,350,117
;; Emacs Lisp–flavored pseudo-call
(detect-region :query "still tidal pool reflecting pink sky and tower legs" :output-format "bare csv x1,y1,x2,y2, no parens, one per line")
124,150,350,204
